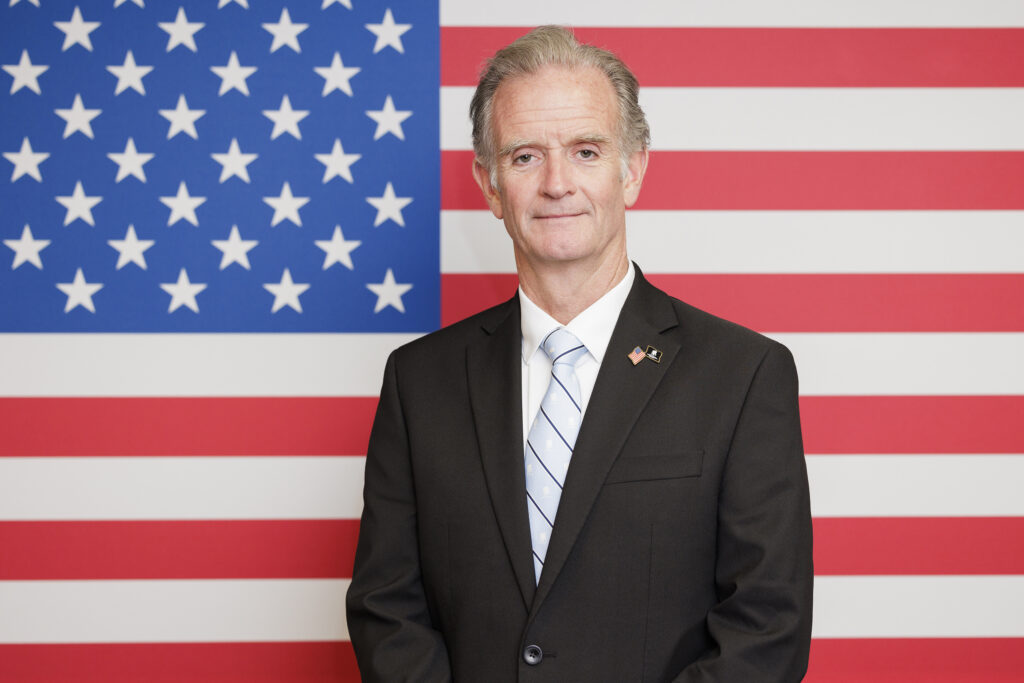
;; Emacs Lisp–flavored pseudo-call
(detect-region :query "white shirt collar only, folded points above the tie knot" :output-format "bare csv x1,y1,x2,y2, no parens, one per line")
519,263,636,366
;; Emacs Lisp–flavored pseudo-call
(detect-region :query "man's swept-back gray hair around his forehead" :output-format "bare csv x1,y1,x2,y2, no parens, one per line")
469,26,650,178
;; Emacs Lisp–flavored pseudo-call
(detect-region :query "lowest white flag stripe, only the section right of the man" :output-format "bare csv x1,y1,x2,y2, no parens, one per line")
812,577,1024,638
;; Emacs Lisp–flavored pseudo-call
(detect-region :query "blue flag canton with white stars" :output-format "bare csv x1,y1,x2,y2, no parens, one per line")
0,0,439,332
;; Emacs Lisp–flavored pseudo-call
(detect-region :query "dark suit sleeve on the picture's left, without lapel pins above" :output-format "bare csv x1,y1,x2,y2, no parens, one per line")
346,353,452,683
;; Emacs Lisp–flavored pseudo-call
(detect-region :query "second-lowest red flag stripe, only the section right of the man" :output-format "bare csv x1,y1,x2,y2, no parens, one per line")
814,517,1024,575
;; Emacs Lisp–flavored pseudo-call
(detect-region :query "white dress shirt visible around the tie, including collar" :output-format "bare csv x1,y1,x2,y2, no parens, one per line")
519,263,635,443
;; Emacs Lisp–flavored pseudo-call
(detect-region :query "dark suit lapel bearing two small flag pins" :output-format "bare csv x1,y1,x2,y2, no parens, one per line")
532,268,680,613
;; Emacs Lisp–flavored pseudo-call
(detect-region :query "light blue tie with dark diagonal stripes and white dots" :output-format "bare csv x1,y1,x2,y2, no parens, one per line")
526,328,587,582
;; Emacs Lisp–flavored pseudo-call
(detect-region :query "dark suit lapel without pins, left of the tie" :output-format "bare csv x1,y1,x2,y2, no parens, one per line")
466,297,537,609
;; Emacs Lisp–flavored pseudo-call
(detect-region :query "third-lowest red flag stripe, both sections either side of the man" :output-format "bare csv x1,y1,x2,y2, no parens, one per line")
0,396,1024,456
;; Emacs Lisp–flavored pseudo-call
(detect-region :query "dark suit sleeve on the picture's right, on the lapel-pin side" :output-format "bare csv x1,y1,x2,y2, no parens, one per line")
675,342,813,683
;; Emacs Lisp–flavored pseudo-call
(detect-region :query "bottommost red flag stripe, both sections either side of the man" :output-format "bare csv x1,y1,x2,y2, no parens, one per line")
0,638,1024,683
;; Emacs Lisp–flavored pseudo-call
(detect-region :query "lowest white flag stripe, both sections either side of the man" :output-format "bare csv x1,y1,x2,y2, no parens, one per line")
0,575,1024,643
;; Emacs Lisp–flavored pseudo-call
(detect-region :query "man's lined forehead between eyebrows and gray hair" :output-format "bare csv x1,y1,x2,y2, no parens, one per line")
492,67,617,145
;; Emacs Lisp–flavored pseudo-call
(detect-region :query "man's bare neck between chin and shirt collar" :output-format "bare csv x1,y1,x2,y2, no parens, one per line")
516,251,630,325
